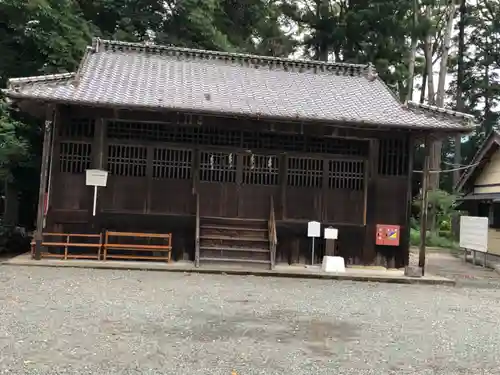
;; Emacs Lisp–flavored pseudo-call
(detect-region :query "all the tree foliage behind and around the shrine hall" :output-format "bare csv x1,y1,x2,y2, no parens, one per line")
0,0,500,225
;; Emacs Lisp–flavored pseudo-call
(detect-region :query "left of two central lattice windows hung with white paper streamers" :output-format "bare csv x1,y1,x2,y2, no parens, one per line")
200,151,236,182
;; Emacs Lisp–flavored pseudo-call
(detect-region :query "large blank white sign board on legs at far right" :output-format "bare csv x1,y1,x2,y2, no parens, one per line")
460,216,488,252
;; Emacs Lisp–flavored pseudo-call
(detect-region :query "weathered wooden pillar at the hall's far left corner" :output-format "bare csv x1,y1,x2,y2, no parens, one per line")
35,105,54,260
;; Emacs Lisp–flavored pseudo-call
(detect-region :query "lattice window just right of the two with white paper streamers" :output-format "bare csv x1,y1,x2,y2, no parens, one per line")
287,157,323,187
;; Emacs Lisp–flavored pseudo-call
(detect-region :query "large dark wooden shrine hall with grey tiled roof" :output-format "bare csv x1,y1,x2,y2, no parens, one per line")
4,39,472,267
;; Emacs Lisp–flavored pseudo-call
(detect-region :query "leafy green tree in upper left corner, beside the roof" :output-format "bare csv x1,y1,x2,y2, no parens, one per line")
0,0,91,85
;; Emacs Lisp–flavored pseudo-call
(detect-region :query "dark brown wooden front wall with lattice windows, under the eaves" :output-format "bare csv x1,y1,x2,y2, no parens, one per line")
47,107,411,266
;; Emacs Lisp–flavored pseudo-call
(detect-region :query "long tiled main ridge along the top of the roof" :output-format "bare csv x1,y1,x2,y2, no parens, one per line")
92,38,376,78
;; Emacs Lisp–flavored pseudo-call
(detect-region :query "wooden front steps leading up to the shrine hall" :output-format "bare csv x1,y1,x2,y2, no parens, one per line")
198,217,271,268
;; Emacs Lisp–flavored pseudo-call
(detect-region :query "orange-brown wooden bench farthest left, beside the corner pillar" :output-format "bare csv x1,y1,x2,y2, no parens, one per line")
31,233,102,260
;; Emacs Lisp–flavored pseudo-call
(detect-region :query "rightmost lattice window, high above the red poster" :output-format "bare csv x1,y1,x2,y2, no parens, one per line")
378,139,410,176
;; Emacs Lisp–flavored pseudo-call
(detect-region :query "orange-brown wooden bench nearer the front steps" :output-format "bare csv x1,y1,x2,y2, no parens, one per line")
103,231,172,262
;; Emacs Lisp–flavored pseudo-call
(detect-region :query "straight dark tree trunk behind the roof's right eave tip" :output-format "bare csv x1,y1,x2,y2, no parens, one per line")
453,0,467,187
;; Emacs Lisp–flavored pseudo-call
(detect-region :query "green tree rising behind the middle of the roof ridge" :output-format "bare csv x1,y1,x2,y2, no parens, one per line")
155,0,294,56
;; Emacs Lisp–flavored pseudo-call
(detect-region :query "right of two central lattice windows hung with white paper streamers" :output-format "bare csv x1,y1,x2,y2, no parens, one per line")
243,154,279,185
